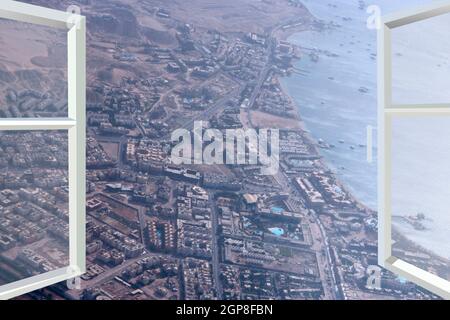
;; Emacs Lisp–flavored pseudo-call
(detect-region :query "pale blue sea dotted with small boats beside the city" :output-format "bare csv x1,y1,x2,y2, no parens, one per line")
282,0,450,258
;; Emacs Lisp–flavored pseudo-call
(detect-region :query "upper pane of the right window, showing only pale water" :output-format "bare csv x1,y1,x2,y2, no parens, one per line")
392,14,450,104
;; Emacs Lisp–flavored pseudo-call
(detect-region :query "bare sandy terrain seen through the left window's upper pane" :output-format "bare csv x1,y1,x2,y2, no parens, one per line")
0,15,67,104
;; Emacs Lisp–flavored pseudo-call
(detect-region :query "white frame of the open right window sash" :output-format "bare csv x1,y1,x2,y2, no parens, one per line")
378,1,450,299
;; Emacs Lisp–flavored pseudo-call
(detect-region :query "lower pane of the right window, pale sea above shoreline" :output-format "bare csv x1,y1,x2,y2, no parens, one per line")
391,115,450,280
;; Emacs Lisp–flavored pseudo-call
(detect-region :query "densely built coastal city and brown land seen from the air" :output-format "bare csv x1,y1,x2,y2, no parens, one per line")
0,0,449,300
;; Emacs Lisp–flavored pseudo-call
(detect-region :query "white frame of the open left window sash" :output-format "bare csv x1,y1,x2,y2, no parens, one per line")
0,0,86,300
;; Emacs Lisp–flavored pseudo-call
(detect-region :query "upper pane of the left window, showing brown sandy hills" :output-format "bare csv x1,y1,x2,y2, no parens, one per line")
0,19,67,118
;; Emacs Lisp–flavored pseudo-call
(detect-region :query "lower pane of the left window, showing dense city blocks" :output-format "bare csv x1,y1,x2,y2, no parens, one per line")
0,131,69,284
